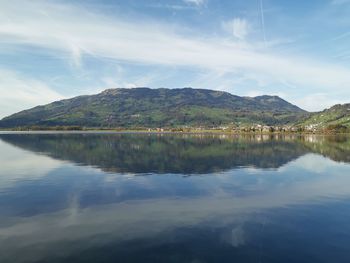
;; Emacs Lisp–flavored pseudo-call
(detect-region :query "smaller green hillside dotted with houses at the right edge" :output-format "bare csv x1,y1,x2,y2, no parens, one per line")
299,103,350,131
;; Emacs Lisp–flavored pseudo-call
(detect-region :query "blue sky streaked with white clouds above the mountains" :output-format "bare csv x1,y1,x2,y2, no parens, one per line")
0,0,350,118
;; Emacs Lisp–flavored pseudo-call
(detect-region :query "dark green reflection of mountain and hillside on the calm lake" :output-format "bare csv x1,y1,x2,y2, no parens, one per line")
0,134,350,174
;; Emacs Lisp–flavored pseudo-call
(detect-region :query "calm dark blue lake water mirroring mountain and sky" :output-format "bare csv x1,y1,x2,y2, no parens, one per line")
0,134,350,263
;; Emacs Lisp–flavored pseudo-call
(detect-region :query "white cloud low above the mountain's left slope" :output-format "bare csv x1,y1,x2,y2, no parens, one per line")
0,69,64,119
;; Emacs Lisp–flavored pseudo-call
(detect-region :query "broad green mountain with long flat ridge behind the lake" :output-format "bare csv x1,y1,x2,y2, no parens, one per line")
0,88,306,127
